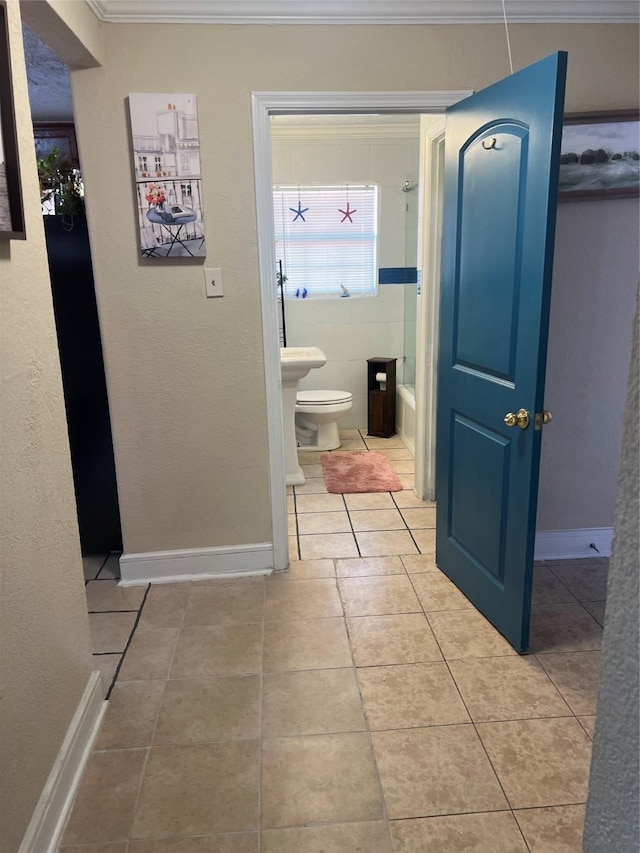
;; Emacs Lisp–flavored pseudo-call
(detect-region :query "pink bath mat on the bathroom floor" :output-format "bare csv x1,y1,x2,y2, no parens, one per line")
320,450,402,495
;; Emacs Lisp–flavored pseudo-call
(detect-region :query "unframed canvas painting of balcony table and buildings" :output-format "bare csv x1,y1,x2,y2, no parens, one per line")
129,94,206,258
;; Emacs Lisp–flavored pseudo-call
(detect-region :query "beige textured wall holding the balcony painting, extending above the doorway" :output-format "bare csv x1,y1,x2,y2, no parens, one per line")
67,24,638,552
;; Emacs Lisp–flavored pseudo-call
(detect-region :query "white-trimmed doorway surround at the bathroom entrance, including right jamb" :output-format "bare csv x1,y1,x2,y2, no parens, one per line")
252,91,471,570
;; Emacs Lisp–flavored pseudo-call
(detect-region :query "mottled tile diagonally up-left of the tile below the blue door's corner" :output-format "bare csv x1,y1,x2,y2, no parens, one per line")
347,613,442,666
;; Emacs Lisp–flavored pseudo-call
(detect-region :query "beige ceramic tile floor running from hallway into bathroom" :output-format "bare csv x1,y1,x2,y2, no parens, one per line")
61,433,607,853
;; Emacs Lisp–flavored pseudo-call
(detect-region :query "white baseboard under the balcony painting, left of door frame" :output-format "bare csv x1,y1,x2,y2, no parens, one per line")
120,542,273,586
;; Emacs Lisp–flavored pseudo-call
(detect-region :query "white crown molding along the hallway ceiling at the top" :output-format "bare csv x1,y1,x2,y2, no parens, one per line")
86,0,640,24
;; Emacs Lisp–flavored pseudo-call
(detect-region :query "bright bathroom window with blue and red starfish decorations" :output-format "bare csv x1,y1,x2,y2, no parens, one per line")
273,184,378,299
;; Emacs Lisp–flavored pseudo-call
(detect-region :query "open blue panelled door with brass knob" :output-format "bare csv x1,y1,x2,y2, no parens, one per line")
436,53,567,651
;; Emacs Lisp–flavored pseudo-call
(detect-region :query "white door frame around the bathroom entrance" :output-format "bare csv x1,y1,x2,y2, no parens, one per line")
251,90,471,570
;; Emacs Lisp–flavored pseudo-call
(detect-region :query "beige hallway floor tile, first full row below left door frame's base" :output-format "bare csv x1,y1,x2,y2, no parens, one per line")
264,578,342,622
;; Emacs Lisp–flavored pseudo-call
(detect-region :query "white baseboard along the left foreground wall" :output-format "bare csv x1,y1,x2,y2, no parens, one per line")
18,671,108,853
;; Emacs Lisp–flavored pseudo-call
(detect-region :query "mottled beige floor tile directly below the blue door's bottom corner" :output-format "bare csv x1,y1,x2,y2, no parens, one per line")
449,655,571,722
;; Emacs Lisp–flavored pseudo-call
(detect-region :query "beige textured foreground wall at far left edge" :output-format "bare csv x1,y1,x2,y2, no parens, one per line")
0,0,91,853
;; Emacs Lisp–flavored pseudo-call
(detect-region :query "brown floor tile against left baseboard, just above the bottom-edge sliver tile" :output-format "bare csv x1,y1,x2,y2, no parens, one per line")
62,749,147,844
